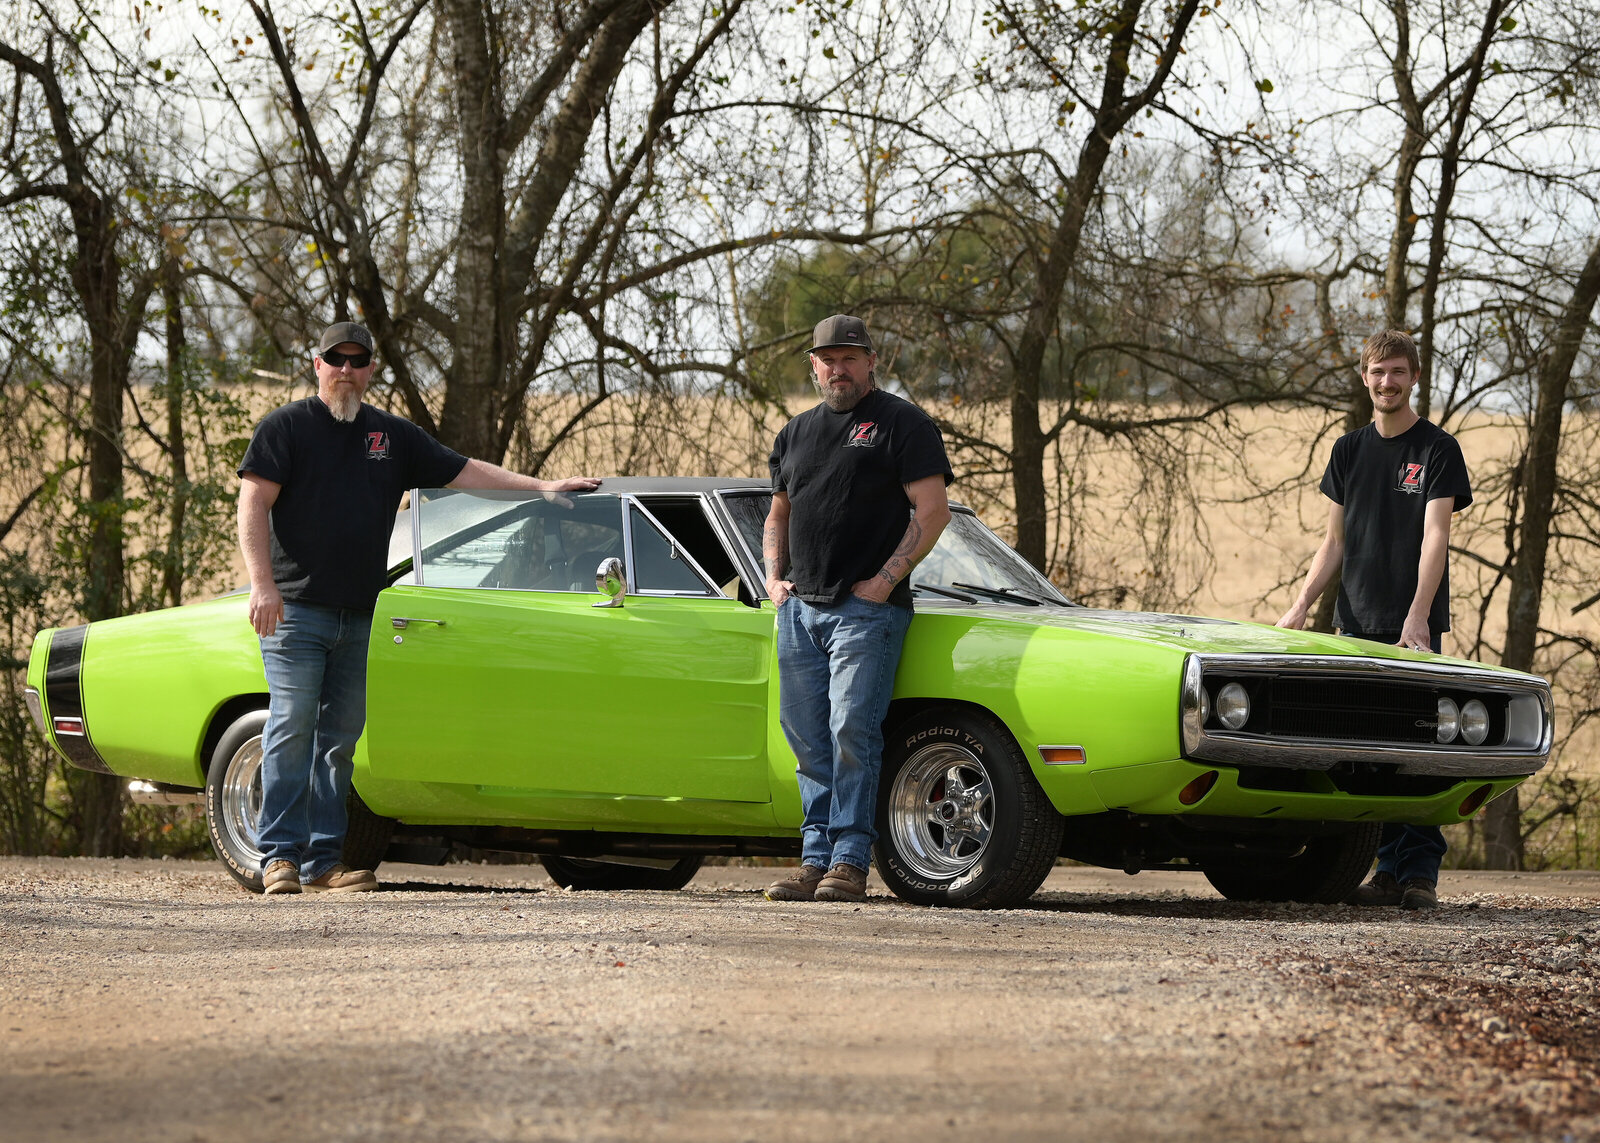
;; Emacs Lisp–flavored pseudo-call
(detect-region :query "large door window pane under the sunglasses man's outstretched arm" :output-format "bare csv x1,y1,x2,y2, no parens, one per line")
400,493,622,592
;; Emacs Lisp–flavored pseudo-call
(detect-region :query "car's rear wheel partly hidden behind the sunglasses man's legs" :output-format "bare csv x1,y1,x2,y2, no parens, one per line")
205,711,394,893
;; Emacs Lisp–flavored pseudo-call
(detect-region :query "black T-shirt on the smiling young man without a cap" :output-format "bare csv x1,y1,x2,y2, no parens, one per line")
1322,421,1472,636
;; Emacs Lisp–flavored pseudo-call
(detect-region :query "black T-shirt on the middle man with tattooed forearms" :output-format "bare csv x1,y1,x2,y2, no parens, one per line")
768,389,955,607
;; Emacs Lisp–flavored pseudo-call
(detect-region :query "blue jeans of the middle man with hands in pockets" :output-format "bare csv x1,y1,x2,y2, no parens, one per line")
778,596,910,869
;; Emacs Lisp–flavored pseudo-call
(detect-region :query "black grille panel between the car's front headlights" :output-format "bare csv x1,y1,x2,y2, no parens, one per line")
1250,677,1438,743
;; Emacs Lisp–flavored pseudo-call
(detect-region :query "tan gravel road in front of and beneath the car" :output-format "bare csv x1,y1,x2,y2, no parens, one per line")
0,858,1600,1143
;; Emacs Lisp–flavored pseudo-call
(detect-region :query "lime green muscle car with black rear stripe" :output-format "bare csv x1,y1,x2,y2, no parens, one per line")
27,479,1552,908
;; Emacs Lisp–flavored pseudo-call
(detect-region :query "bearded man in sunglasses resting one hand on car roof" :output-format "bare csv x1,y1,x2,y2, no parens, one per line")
238,322,600,895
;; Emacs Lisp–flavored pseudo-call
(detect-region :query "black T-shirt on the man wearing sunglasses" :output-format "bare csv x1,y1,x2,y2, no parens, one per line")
238,397,467,612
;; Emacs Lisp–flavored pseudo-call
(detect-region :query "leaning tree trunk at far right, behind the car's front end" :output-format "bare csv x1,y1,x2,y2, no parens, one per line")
1483,240,1600,869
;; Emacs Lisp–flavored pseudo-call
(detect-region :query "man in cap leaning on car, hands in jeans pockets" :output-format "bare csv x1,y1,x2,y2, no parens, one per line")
762,315,954,901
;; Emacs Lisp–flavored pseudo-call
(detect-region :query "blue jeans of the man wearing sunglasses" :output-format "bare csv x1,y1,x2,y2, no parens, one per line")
256,602,373,880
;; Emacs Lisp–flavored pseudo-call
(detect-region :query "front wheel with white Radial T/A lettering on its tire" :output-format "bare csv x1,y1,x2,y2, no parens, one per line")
874,708,1064,909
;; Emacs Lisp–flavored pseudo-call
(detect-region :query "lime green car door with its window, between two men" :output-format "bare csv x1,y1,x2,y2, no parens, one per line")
366,491,773,802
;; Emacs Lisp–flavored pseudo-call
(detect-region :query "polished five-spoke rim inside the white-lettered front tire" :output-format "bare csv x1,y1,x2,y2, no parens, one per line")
888,743,995,880
